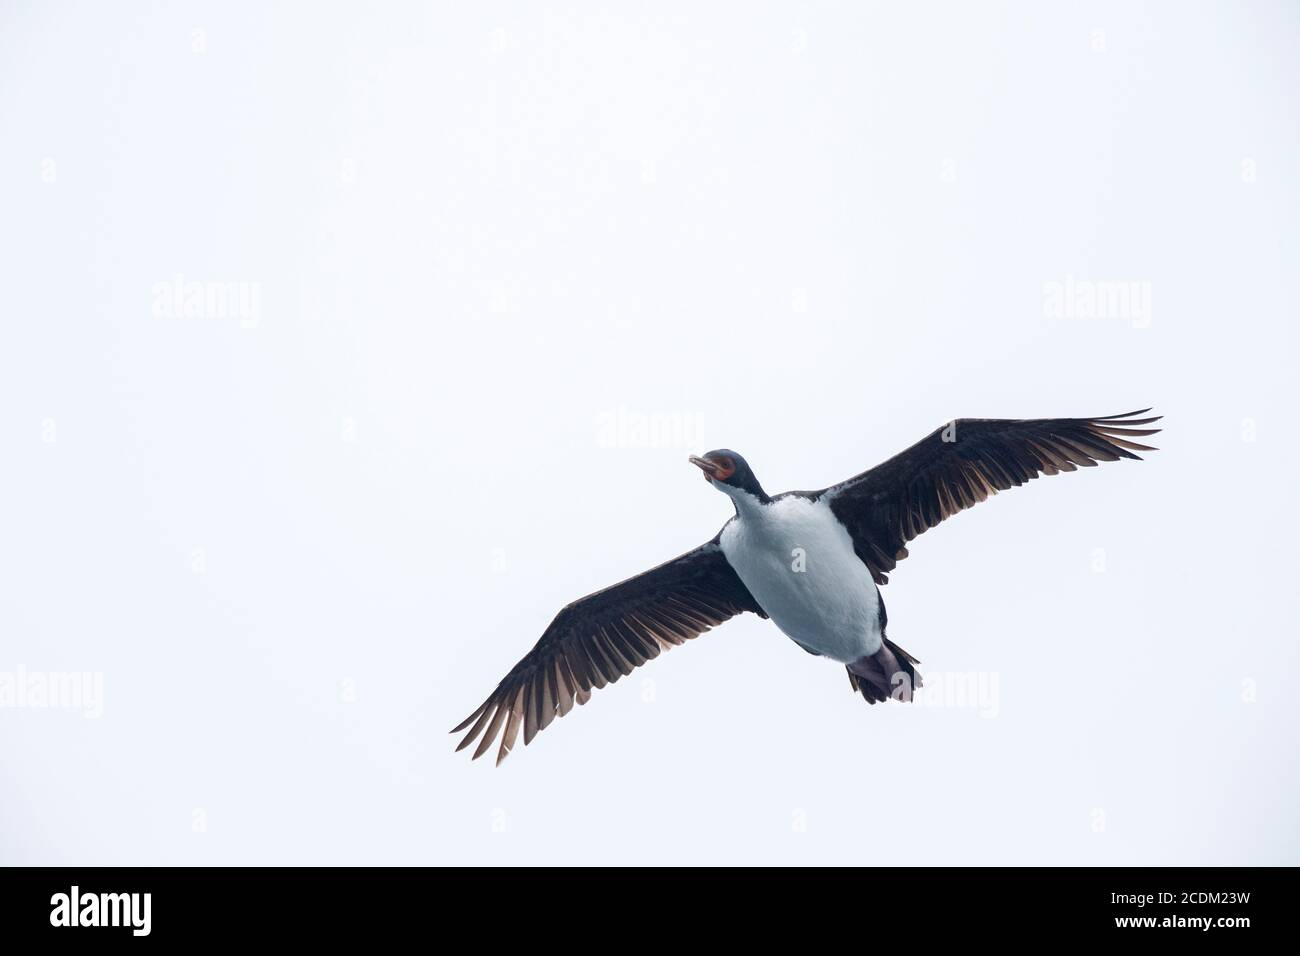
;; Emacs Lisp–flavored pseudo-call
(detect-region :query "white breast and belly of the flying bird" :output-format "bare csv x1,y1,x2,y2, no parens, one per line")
719,496,880,663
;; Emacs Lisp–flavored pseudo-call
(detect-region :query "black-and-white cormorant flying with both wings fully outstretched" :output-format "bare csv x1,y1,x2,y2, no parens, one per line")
451,408,1161,763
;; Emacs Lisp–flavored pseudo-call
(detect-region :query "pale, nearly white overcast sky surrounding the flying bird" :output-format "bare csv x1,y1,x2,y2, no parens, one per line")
0,1,1300,865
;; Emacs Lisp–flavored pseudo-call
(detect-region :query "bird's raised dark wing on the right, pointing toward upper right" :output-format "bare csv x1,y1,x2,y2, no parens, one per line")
816,408,1161,584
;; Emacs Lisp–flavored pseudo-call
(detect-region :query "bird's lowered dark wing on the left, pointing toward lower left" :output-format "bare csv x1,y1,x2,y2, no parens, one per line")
451,537,762,763
